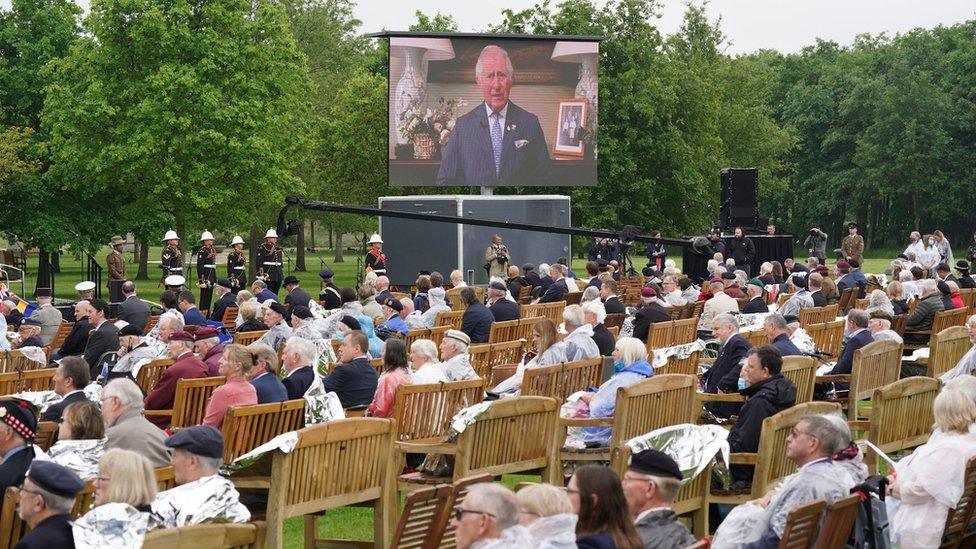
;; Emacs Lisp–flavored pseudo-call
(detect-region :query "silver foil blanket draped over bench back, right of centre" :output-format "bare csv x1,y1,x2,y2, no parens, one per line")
627,423,729,484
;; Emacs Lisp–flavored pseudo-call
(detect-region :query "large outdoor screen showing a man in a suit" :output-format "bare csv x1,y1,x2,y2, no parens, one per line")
389,34,599,187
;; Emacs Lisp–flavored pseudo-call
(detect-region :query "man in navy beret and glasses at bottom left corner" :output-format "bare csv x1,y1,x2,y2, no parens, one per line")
14,460,85,549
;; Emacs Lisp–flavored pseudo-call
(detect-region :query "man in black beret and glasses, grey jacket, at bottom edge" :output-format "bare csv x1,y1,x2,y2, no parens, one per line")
620,450,695,549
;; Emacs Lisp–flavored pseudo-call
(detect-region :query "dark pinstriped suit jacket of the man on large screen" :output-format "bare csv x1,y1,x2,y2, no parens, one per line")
437,101,551,187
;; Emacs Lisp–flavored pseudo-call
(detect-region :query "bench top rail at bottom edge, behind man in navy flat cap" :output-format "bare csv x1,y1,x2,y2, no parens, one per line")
142,521,267,549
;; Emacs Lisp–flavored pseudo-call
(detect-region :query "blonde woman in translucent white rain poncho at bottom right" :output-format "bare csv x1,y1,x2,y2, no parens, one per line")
886,389,976,548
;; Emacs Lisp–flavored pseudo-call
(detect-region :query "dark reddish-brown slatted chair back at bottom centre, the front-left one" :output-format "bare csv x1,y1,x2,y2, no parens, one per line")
390,484,453,549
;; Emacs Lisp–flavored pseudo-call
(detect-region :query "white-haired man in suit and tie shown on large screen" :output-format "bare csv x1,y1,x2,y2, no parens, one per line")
437,45,550,187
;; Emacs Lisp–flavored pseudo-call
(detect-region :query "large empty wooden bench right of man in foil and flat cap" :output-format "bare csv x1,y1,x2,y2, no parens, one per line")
267,418,397,547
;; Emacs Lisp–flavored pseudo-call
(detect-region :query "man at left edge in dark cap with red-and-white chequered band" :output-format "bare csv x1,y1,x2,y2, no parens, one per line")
0,399,37,503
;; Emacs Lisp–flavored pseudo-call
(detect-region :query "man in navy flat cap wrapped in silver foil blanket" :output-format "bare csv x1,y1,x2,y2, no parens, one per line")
149,425,251,528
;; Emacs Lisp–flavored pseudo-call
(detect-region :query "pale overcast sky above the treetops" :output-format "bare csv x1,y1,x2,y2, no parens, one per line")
0,0,976,53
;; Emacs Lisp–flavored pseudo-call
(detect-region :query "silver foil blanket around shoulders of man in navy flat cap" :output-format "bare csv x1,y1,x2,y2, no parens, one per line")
149,475,251,530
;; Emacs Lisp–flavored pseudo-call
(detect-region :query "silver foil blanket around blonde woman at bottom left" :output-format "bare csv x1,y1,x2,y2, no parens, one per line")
72,503,149,549
